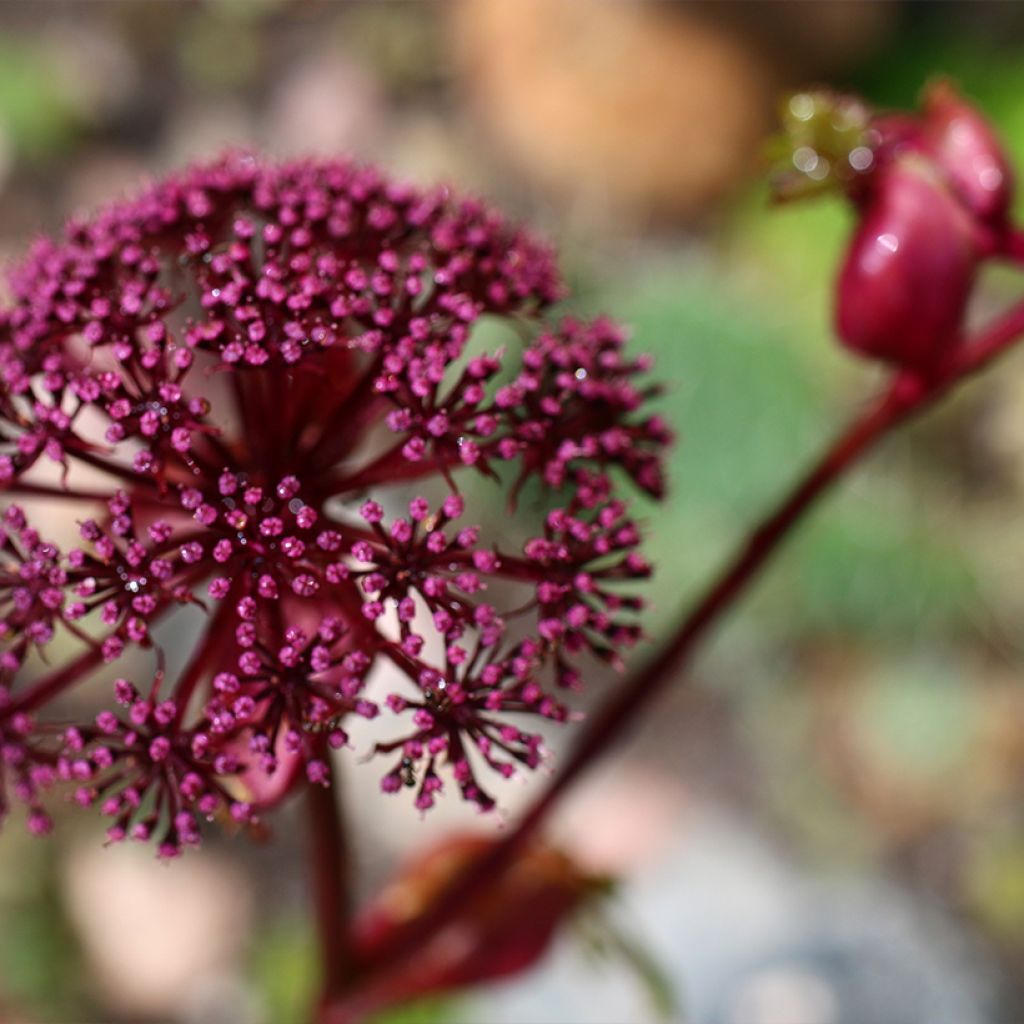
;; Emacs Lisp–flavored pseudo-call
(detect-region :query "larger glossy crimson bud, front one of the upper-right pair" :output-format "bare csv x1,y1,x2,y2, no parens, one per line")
836,155,980,372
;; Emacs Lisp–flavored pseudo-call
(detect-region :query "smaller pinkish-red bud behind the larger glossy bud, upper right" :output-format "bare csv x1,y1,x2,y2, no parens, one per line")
923,82,1014,226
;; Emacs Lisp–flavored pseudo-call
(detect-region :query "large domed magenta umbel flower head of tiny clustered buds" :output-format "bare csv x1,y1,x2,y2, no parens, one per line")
0,156,669,856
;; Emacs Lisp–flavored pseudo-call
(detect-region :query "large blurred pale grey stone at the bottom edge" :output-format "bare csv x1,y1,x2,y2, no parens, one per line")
470,805,1007,1024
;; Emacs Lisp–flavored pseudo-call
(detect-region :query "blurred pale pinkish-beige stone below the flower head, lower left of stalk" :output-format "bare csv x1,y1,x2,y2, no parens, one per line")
63,841,252,1021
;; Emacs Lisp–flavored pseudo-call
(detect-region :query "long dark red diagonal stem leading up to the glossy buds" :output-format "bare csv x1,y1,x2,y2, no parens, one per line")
342,303,1024,991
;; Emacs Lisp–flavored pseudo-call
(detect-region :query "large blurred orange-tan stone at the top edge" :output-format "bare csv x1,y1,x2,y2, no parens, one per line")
452,0,773,221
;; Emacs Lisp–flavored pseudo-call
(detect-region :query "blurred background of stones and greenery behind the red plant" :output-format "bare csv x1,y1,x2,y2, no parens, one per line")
6,0,1024,1024
